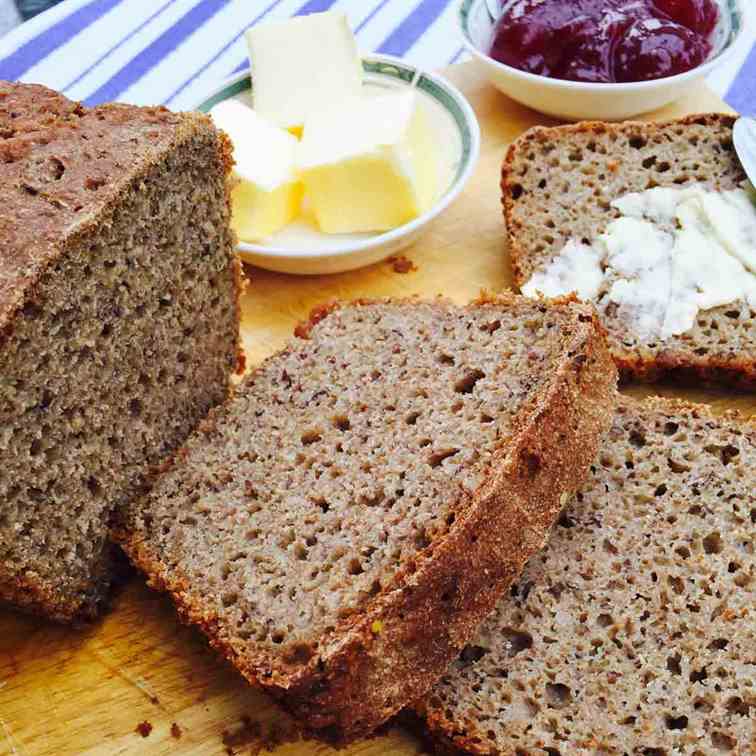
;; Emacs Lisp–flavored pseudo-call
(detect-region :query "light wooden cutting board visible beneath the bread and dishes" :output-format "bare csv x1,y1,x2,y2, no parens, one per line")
0,64,756,756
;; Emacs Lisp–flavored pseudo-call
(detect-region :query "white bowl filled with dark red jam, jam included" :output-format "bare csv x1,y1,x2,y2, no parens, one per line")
459,0,745,120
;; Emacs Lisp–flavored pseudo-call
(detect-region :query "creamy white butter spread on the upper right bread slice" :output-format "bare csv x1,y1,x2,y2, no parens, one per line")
522,185,756,342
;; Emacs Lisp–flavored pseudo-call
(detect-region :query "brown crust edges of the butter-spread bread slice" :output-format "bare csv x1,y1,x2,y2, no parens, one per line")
500,113,756,390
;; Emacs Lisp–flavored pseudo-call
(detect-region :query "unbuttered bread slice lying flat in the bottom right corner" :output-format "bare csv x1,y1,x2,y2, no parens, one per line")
418,400,756,756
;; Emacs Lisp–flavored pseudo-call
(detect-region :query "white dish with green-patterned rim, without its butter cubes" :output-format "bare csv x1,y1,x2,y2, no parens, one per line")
196,55,480,275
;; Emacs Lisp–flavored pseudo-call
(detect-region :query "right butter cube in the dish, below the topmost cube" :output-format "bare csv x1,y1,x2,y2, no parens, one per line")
298,90,438,233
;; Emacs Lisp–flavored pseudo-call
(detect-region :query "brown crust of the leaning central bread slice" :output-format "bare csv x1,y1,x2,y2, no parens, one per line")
118,295,616,745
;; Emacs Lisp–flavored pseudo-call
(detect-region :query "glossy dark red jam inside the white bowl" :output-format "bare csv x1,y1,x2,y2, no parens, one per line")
491,0,719,83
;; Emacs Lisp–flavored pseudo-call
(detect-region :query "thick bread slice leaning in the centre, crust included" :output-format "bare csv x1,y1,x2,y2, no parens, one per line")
115,296,616,742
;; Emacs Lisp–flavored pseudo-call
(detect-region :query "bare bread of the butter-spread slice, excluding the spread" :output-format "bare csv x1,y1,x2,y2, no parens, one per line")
502,114,756,389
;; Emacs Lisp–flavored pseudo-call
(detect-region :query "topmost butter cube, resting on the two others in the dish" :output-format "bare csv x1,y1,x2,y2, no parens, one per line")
246,11,362,134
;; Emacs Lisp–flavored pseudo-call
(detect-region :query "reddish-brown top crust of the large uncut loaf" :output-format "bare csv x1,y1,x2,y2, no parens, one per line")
0,80,243,370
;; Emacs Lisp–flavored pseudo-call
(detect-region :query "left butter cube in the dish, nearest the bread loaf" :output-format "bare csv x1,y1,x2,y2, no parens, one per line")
210,100,303,242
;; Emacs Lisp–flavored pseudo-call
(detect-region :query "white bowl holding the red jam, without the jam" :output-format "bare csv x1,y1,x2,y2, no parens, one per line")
459,0,752,121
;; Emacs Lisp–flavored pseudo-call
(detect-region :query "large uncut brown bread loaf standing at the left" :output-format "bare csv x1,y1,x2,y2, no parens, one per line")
0,82,239,621
